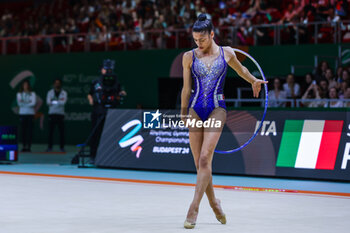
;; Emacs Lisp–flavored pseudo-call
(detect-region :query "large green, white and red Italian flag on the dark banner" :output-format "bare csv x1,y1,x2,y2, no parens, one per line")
276,120,343,170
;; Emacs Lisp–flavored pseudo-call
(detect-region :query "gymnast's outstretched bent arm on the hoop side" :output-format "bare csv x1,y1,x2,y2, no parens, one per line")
224,47,268,98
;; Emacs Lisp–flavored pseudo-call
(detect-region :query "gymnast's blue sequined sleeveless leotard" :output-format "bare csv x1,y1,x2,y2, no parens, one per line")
188,47,227,121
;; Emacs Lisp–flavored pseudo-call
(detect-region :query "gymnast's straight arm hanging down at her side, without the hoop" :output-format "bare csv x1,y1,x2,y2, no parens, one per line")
181,51,192,120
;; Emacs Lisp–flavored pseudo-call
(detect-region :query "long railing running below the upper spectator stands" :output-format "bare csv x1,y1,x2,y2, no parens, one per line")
0,21,350,55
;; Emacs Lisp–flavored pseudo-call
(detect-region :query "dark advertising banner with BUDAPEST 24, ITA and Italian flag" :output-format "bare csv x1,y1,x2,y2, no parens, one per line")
96,110,350,180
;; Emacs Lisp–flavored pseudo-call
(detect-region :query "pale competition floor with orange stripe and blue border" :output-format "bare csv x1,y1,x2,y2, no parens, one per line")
0,147,350,233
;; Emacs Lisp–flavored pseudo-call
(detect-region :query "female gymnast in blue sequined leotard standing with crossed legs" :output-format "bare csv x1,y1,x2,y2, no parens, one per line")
181,14,267,229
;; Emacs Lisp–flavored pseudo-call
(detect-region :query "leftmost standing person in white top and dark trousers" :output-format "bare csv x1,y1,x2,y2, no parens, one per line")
17,80,36,152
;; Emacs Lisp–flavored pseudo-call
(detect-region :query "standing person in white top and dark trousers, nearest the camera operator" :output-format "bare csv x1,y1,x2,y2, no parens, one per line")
46,79,68,152
